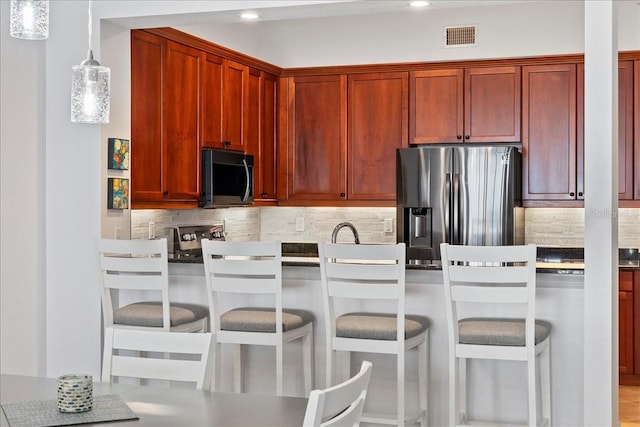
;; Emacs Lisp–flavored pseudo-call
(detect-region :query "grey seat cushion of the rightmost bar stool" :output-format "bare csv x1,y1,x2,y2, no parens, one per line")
458,318,551,347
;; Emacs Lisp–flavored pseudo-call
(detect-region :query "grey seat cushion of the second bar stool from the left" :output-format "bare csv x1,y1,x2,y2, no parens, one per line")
220,307,315,333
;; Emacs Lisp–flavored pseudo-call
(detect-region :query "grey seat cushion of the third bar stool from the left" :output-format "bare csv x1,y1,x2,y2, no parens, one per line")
336,312,430,340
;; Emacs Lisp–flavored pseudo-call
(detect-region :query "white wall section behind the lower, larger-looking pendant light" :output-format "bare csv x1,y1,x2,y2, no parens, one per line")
44,1,101,377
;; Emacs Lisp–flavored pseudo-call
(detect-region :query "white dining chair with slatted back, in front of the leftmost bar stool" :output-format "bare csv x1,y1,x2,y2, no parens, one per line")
102,327,213,390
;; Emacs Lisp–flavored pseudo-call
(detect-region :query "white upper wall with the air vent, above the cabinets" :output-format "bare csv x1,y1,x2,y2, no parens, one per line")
176,0,640,68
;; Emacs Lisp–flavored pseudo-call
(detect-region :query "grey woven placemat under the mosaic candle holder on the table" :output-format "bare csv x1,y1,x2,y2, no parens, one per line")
0,394,139,427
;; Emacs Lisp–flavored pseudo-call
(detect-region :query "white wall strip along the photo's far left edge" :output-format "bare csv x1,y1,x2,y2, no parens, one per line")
0,1,45,374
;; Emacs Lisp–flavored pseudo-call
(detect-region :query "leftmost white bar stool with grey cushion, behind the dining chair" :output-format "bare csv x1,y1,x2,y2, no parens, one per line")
98,239,209,332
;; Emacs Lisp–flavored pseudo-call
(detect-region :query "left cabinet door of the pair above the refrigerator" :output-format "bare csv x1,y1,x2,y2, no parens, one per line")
409,69,464,144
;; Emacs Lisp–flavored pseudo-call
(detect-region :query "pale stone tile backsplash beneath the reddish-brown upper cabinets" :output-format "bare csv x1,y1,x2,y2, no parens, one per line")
131,207,640,248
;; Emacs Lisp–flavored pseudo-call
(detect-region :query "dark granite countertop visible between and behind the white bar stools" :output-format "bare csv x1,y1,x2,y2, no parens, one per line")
169,242,640,274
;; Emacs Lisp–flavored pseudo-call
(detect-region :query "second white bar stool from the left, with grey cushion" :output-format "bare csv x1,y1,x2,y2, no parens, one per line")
202,240,315,396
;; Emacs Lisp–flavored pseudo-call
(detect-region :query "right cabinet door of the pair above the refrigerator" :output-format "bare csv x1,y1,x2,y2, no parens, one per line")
464,67,521,142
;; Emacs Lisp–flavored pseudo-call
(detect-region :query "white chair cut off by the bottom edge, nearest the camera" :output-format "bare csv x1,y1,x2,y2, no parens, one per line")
302,360,372,427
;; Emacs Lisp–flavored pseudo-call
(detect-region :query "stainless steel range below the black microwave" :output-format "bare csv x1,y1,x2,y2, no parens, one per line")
169,224,224,261
